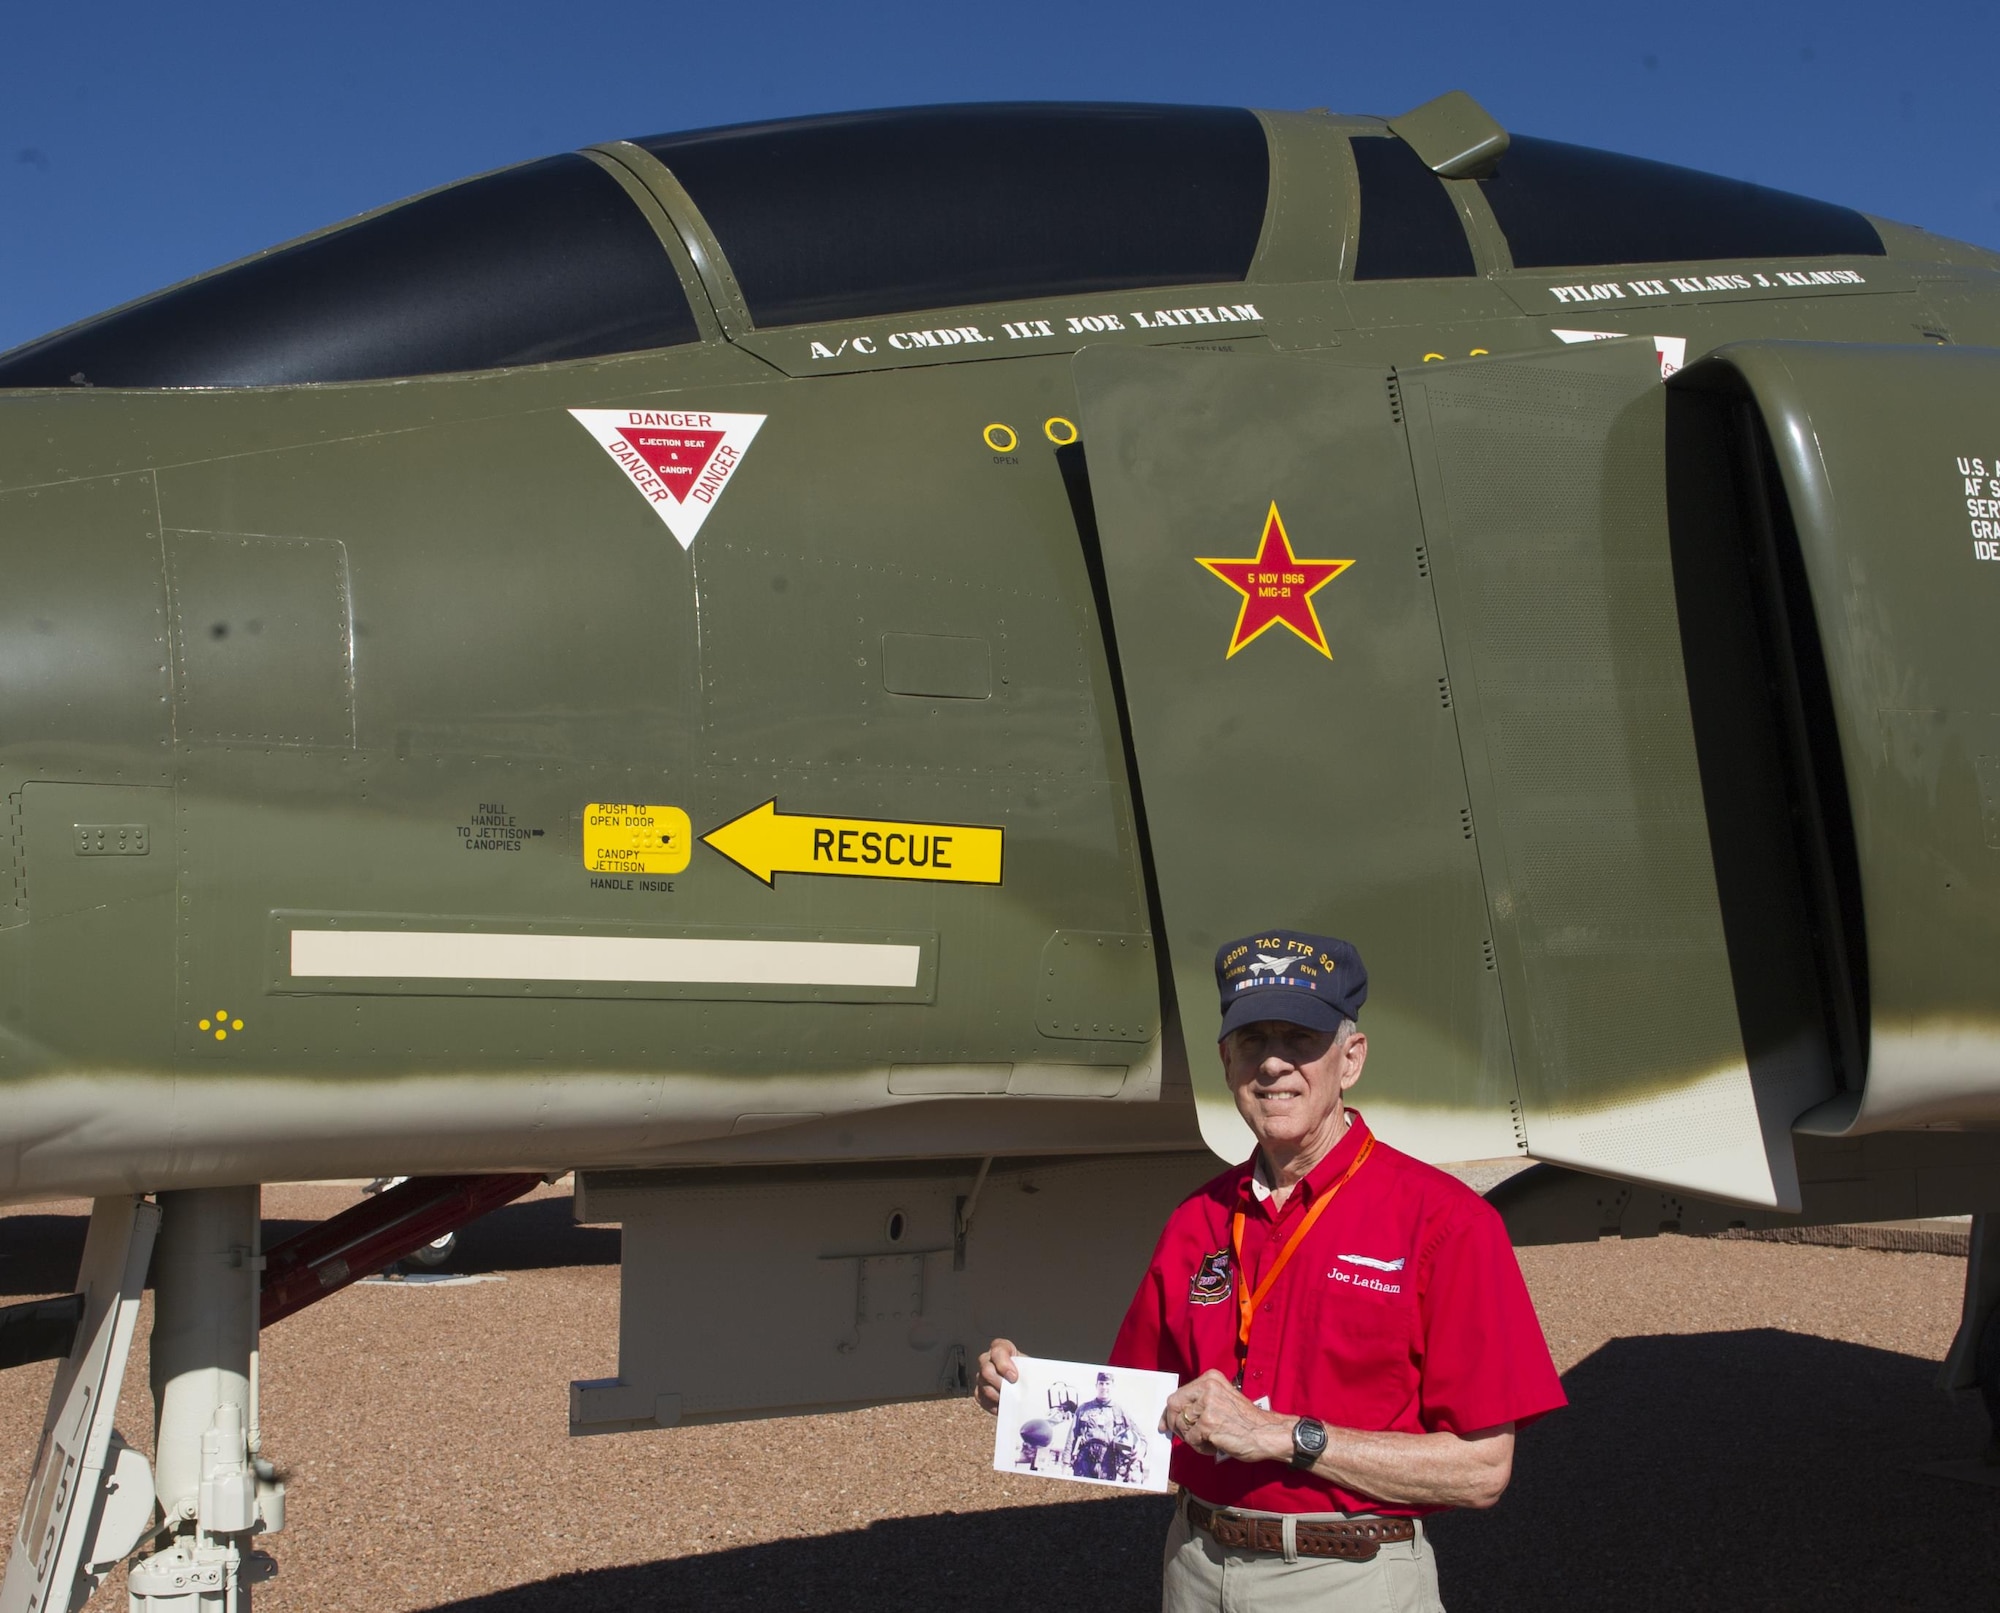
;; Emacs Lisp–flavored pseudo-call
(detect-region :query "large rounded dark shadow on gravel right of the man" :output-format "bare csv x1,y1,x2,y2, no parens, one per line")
1436,1328,2000,1613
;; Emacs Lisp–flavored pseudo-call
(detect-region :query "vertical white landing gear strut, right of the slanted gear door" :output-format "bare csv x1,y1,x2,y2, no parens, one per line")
126,1187,284,1613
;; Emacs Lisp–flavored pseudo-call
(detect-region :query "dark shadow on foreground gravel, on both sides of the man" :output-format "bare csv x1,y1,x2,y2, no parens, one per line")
418,1329,2000,1613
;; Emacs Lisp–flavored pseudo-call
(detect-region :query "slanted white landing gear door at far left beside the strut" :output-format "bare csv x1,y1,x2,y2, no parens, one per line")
0,1197,160,1613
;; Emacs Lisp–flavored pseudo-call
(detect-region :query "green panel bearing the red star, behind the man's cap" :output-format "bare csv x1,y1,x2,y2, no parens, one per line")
1074,348,1522,1161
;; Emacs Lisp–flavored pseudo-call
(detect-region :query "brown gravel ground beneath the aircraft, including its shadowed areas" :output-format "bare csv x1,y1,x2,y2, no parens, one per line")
0,1187,2000,1613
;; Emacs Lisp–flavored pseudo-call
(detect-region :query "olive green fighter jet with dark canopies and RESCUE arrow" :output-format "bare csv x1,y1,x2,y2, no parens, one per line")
0,92,2000,1611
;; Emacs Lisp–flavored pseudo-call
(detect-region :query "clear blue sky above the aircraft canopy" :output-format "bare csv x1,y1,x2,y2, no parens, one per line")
0,0,2000,348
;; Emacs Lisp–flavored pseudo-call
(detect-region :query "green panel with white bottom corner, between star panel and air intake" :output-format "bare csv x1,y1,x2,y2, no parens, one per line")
1402,342,1824,1209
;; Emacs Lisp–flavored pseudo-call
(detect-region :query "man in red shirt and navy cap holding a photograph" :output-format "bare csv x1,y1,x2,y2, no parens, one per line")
978,931,1564,1613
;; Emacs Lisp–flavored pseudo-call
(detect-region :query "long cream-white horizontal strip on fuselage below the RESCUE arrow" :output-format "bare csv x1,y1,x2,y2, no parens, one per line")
292,931,924,989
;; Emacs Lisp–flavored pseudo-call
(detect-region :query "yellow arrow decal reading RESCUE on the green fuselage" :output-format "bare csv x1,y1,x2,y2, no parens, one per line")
702,796,1002,885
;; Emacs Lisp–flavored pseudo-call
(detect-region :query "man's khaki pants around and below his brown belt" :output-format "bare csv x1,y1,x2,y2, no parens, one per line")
1160,1505,1444,1613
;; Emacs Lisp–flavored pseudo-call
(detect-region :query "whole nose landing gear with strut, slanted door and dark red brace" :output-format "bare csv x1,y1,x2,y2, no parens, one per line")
0,1175,542,1613
